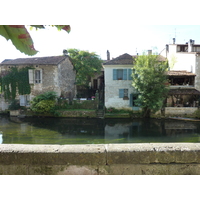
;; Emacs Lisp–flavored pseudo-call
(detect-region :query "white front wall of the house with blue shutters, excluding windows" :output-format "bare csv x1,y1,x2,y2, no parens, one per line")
104,65,135,110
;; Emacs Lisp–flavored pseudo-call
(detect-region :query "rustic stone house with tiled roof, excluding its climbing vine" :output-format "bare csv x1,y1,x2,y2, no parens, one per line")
0,55,76,110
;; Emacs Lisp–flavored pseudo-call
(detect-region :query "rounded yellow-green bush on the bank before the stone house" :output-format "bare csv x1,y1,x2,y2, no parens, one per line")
31,91,57,113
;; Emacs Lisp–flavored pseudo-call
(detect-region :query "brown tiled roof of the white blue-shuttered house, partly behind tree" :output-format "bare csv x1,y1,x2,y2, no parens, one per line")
103,53,166,65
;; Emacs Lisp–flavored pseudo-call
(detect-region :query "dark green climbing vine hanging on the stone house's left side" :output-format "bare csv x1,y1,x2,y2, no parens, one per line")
0,67,32,100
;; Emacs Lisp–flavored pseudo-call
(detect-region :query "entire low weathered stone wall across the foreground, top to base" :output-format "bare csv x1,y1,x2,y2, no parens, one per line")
0,143,200,175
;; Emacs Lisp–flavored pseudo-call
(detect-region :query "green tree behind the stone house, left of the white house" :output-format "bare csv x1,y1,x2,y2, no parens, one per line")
67,49,102,87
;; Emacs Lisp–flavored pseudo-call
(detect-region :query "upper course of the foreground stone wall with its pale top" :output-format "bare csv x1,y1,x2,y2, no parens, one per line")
0,143,200,166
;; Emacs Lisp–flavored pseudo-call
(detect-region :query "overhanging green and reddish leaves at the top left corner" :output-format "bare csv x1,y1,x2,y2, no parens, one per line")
0,25,71,56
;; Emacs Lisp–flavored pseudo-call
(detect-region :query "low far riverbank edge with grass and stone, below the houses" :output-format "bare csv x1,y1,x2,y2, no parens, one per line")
1,107,200,119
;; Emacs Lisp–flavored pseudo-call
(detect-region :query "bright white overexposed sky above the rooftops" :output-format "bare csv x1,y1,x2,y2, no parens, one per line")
0,24,200,62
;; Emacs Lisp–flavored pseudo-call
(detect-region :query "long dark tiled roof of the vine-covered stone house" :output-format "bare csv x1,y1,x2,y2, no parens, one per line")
0,56,67,65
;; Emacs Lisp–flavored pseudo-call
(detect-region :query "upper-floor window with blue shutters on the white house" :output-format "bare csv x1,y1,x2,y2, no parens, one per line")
113,69,132,80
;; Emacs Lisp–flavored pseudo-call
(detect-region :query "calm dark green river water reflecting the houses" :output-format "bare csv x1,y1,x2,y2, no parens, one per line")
0,116,200,144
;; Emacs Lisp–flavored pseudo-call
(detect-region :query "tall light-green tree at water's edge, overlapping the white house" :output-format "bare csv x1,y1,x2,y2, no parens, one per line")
132,55,168,117
